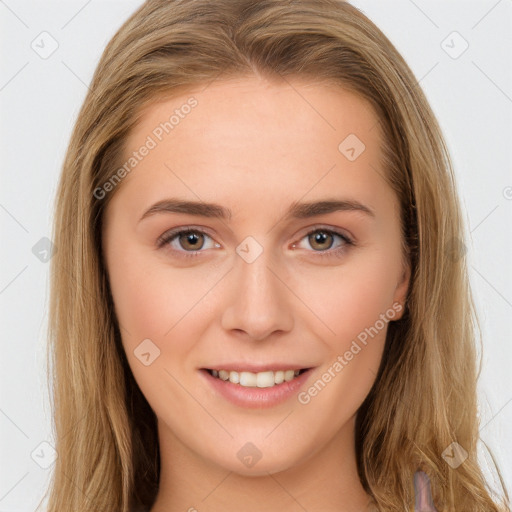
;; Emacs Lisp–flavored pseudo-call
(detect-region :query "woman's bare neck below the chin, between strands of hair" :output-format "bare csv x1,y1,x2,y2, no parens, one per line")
151,419,370,512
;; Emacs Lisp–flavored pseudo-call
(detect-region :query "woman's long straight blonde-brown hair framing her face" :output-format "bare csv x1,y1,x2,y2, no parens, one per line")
44,0,509,512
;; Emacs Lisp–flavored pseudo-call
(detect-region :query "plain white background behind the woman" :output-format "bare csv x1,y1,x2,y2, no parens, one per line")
0,0,512,512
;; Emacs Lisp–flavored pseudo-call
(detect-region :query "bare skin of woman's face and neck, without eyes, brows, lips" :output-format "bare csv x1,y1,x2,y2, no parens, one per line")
103,77,410,512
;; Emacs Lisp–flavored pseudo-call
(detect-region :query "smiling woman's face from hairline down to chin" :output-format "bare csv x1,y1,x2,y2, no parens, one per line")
102,78,409,475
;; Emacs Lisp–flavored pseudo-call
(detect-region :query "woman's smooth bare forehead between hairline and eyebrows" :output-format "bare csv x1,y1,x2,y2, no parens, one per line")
106,77,386,222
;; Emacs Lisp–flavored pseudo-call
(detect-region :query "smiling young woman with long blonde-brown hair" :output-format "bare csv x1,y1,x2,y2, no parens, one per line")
43,0,508,512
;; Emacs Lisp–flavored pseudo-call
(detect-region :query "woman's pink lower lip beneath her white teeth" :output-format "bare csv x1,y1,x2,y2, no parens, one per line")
200,368,313,409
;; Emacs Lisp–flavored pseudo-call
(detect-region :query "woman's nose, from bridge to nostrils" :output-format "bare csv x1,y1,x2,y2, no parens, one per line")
222,247,293,341
